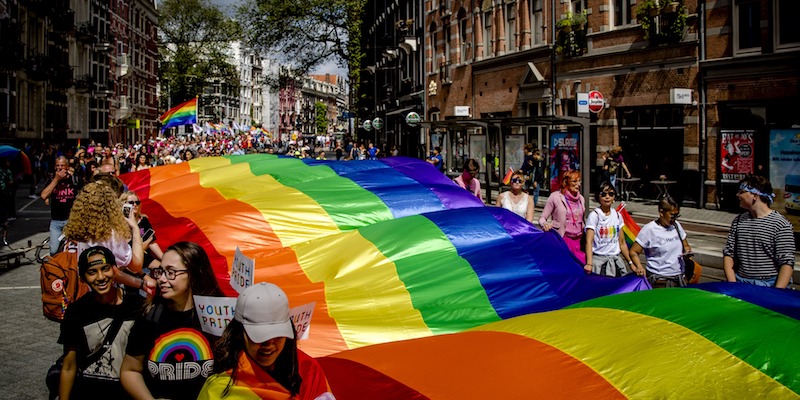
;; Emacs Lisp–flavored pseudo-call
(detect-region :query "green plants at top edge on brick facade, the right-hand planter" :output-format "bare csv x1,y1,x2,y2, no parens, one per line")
636,0,686,44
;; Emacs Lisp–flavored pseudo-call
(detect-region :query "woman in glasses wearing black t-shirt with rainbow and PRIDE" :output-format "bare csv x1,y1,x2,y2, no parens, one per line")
120,242,223,399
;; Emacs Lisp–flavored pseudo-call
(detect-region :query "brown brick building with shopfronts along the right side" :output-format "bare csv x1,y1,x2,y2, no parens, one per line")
416,0,800,206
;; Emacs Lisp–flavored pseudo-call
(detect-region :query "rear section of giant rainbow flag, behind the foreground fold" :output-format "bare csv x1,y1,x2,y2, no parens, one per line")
123,154,648,355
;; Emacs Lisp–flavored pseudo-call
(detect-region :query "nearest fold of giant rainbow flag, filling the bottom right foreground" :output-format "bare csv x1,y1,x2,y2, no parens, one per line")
319,283,800,400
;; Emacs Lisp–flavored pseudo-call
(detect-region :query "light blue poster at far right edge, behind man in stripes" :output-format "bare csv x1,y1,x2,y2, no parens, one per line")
769,129,800,232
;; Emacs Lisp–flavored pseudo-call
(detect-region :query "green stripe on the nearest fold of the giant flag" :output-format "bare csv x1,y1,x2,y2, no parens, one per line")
568,288,800,393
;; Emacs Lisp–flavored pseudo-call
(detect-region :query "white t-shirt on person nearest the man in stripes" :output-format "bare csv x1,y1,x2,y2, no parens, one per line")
636,221,686,276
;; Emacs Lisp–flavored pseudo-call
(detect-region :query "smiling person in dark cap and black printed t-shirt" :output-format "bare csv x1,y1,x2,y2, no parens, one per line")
58,246,143,400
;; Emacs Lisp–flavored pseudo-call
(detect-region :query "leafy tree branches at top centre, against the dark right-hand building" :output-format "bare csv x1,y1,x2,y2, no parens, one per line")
238,0,366,92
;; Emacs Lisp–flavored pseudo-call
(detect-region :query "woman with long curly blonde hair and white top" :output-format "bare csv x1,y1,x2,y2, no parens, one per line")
64,182,144,275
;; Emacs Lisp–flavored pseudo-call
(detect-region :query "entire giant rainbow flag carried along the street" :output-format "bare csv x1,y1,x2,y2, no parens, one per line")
123,155,800,399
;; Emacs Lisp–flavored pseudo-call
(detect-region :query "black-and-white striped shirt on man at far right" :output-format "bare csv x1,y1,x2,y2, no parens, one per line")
722,210,794,279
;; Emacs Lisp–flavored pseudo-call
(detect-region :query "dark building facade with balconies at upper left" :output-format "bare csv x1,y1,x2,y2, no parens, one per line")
0,0,157,147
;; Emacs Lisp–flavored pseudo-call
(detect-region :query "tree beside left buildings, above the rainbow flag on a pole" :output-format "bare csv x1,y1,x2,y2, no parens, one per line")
158,0,241,110
